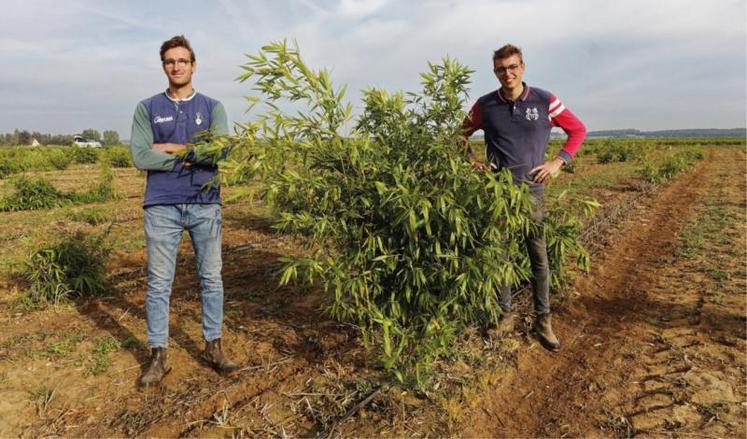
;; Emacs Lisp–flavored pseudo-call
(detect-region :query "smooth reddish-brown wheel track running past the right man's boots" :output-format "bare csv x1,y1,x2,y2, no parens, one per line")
463,150,744,437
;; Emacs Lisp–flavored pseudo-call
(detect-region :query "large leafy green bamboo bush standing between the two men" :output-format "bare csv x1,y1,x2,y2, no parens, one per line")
223,42,592,386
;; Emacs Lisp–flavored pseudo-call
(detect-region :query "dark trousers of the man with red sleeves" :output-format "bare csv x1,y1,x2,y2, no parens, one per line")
499,192,550,315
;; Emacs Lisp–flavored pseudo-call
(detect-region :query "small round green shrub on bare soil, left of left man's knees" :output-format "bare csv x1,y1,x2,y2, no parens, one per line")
21,230,111,305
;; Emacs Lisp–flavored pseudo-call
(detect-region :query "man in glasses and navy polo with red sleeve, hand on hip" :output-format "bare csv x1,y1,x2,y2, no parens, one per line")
464,44,586,351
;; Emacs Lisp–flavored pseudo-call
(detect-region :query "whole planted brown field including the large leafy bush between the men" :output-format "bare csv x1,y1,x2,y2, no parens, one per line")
0,46,747,437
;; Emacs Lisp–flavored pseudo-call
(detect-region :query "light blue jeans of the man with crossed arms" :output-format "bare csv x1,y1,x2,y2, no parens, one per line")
143,204,223,348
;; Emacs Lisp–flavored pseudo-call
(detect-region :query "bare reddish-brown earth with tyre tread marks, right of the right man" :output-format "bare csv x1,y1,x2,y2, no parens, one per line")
463,150,747,437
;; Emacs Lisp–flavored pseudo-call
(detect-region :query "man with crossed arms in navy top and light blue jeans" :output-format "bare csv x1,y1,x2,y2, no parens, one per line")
130,35,238,386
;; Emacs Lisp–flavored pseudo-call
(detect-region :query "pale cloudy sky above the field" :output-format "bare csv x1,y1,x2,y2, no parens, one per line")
0,0,747,139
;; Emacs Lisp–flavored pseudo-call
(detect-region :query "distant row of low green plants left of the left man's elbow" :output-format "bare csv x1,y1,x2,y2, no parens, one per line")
0,146,132,178
